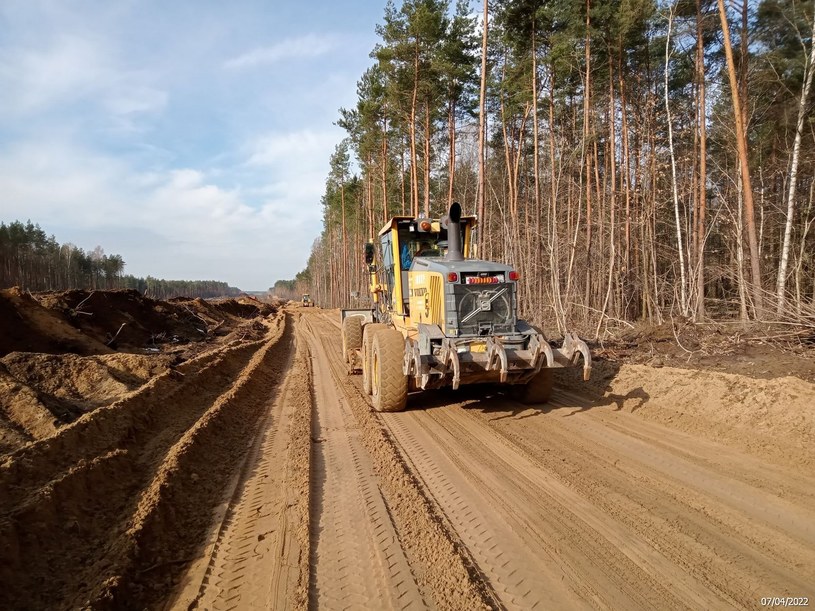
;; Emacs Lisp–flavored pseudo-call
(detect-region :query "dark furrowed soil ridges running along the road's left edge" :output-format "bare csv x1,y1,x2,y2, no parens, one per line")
0,321,290,609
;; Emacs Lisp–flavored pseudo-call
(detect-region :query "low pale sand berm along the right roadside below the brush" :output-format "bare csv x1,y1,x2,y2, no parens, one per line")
559,361,815,469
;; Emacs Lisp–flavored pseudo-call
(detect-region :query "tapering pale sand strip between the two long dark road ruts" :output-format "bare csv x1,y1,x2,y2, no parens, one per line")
305,323,426,609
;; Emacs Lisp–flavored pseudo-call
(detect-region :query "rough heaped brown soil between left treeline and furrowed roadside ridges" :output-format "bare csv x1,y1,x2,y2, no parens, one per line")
0,288,278,456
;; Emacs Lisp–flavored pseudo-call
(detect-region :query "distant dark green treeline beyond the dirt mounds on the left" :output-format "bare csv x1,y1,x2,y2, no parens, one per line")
0,220,241,299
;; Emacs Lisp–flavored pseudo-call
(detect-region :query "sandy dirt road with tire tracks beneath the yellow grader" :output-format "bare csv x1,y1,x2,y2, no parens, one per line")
169,310,815,609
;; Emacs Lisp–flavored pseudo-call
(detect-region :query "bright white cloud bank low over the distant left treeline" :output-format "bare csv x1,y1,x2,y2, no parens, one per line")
0,140,321,290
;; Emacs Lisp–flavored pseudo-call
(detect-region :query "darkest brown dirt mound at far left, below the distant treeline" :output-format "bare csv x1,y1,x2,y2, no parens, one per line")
0,287,113,355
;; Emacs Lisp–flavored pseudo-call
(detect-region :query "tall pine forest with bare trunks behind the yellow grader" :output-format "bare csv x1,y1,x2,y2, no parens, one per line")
295,0,815,332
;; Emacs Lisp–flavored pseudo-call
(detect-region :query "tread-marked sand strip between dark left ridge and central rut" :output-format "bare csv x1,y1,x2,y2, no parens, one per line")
167,318,311,611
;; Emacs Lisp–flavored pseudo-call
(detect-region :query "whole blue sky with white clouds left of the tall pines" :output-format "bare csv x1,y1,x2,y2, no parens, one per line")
0,0,385,290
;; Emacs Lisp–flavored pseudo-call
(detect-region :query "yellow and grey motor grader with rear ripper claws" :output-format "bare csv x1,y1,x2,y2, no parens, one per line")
341,202,591,412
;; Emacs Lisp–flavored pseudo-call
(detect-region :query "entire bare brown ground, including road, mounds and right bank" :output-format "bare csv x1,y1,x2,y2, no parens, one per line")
0,296,815,610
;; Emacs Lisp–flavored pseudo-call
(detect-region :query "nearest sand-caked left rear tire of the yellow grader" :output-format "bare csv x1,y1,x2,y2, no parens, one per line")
371,329,407,412
